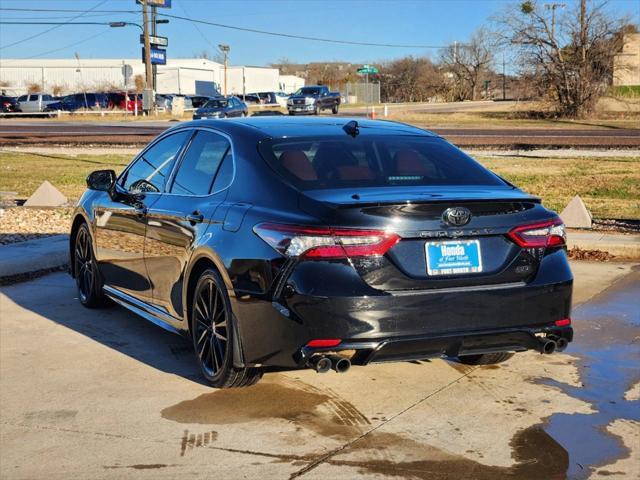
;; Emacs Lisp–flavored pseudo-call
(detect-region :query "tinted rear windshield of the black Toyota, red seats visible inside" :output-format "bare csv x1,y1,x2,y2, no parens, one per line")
260,135,507,190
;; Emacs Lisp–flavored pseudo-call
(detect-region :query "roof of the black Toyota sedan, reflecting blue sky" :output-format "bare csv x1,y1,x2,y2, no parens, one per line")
180,115,437,138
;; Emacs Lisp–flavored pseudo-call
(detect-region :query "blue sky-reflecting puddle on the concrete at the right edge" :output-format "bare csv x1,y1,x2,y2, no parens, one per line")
542,272,640,479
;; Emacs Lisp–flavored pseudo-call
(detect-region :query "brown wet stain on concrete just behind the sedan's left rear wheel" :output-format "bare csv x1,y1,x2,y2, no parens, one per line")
161,375,369,437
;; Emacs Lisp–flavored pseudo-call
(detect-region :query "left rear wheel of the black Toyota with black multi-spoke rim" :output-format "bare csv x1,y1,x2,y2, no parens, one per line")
191,269,263,388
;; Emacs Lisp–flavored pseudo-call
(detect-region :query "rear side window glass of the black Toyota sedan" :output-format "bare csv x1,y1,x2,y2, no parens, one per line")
171,130,231,195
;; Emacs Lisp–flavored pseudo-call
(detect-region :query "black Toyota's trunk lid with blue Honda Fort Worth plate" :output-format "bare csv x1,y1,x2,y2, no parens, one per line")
300,186,550,291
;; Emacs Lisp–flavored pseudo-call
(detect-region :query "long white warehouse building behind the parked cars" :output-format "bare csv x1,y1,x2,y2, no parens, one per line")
0,58,304,95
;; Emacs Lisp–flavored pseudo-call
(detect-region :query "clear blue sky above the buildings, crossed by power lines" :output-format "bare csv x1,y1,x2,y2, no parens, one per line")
0,0,640,65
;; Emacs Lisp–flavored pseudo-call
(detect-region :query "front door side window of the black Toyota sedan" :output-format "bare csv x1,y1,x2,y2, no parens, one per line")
119,130,191,193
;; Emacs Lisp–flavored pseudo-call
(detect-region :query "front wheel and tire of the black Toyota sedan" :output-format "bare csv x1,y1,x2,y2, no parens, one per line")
73,223,109,308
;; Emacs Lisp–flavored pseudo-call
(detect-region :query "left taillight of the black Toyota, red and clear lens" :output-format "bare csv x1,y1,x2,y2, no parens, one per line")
253,223,400,260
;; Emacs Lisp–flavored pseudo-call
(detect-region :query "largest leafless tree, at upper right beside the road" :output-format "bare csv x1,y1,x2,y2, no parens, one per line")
499,0,624,117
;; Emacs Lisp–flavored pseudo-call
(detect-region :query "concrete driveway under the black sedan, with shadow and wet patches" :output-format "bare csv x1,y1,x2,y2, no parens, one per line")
0,263,640,479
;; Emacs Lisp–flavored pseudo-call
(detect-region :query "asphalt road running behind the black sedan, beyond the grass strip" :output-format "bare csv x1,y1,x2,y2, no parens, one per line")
0,117,640,149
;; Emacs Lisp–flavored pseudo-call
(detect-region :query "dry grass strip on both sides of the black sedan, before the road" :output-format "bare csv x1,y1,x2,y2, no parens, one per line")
0,151,640,219
